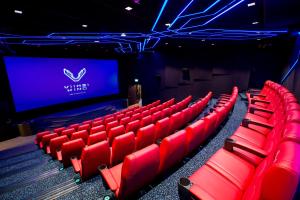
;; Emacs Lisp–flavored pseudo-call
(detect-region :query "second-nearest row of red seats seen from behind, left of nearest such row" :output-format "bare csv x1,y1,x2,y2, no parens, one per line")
64,92,211,180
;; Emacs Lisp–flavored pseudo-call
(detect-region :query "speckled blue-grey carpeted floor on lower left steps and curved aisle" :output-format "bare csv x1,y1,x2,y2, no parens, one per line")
0,97,246,200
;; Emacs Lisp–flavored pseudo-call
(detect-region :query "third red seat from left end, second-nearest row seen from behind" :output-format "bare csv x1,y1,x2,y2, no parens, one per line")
135,124,155,150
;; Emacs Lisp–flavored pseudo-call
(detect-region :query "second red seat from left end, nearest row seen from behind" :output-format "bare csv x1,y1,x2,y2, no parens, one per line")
159,130,186,173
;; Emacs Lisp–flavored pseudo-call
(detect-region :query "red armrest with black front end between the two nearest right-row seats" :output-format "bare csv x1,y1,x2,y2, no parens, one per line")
223,138,267,158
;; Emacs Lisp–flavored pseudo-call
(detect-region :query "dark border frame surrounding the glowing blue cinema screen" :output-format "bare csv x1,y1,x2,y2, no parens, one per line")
1,55,122,118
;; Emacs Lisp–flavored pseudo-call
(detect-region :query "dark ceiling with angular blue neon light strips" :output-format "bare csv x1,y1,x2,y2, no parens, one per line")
0,0,300,53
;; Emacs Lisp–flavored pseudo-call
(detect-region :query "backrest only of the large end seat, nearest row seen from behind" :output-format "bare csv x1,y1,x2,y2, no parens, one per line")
117,144,159,199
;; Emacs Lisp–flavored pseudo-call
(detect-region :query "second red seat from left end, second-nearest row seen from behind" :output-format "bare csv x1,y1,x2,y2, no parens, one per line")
110,132,135,166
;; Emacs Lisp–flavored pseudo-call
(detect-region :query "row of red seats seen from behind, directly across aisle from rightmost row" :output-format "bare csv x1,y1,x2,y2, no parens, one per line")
99,87,237,199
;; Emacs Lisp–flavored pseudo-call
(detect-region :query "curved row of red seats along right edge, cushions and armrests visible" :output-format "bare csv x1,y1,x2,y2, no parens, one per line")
178,81,300,200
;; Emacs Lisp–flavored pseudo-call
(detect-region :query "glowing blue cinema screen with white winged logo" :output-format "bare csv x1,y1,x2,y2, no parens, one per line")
4,56,119,112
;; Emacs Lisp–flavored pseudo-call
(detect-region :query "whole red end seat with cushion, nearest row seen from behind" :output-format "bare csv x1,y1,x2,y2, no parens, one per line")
100,144,159,199
